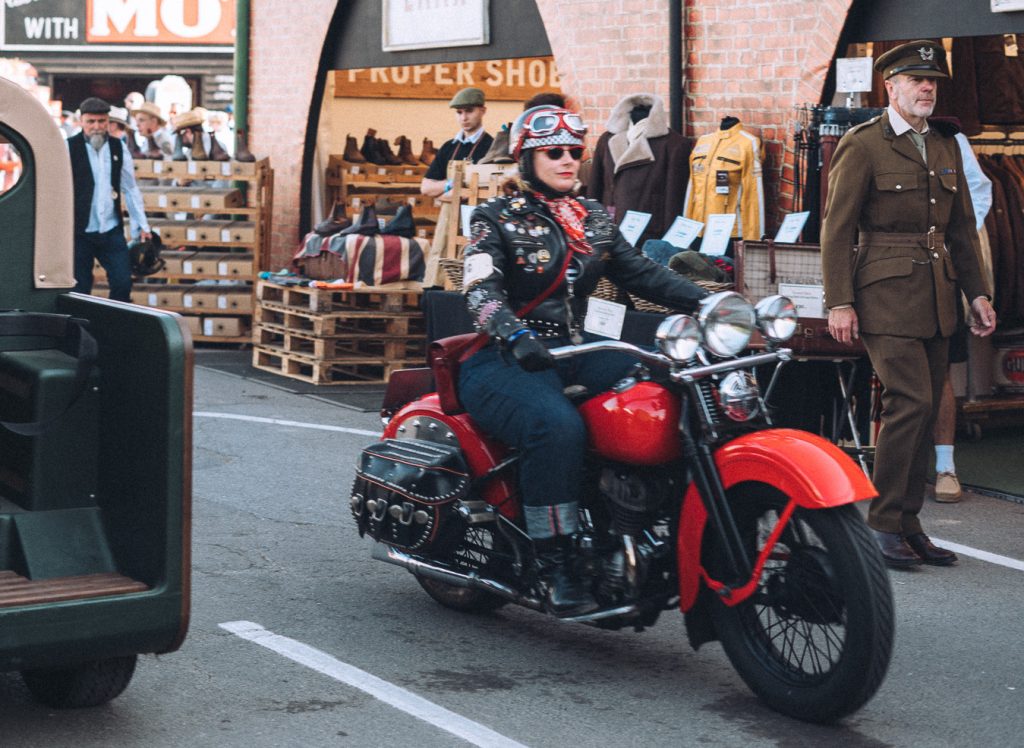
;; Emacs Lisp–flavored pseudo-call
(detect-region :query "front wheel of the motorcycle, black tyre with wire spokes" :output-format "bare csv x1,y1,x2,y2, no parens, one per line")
712,484,895,722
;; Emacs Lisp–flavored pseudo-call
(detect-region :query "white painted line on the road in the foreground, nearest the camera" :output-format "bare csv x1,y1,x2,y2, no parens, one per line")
220,621,525,748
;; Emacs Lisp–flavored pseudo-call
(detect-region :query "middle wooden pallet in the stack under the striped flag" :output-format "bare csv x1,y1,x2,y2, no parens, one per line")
253,325,426,361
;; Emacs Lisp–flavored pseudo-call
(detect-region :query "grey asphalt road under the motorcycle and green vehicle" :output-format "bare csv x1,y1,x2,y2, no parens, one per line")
0,367,1024,748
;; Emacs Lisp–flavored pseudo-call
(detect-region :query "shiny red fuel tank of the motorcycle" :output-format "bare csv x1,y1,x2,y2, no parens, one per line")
580,382,683,465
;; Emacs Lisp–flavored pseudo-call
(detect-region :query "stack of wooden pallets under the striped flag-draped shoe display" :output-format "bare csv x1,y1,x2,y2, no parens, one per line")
253,281,426,385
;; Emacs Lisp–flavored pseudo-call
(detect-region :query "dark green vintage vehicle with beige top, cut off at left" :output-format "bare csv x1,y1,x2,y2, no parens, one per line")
0,79,193,707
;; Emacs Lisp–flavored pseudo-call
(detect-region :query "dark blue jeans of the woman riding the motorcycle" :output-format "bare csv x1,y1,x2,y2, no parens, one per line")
459,341,637,506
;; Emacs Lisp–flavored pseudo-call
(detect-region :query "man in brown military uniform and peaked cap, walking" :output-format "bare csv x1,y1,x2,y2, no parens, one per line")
821,41,995,567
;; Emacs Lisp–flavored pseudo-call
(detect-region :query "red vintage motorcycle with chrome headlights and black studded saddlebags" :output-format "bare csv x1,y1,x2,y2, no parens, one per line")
351,292,894,722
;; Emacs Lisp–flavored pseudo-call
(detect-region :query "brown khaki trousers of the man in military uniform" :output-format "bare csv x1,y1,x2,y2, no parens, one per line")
860,333,949,536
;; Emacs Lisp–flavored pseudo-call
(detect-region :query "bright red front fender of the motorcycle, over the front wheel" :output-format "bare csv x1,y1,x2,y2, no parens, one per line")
678,428,878,613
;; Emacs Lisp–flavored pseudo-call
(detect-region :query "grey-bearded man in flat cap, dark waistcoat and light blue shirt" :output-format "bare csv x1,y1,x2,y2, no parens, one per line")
68,97,153,301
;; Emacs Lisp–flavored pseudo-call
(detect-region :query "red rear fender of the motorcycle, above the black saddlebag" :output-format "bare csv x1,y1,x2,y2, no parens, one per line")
383,392,519,520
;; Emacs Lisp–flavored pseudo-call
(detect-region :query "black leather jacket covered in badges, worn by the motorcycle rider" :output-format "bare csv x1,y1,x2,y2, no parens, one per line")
464,190,708,340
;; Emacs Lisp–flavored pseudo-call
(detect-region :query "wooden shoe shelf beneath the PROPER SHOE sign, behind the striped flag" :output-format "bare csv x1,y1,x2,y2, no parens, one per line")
327,156,439,240
